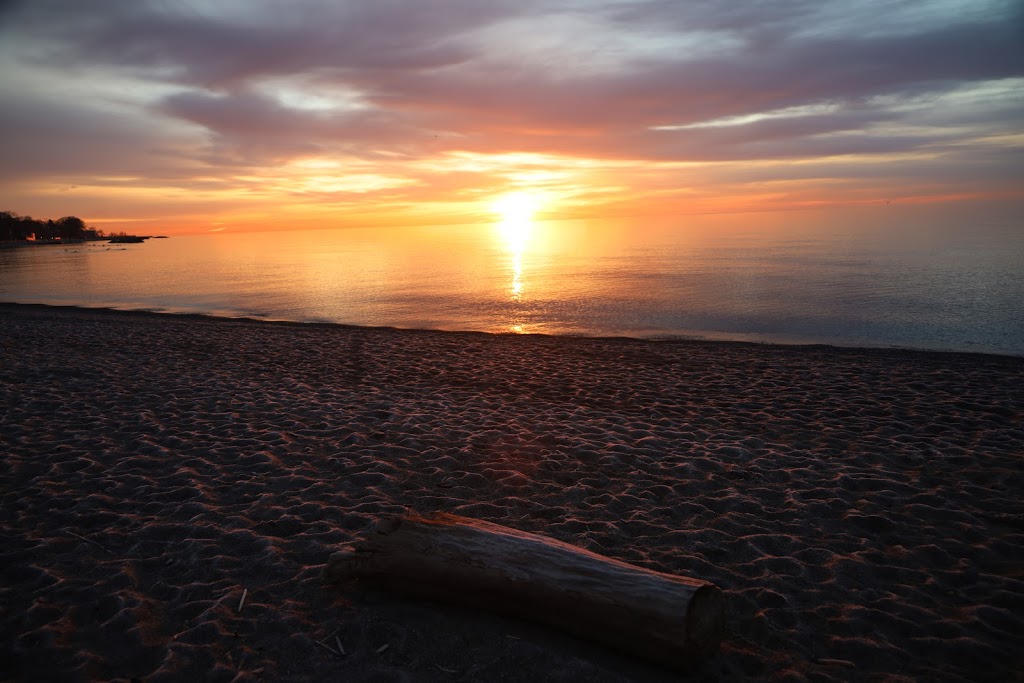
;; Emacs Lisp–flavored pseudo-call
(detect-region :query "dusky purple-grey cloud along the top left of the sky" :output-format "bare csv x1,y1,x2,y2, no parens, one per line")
4,0,520,89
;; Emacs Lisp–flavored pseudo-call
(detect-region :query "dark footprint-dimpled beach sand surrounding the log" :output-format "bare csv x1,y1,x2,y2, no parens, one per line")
0,305,1024,683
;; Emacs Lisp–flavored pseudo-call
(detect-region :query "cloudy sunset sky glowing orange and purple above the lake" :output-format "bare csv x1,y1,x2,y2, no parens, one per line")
0,0,1024,233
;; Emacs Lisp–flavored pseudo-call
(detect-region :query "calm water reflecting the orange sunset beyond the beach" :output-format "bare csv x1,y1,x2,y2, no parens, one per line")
0,207,1024,355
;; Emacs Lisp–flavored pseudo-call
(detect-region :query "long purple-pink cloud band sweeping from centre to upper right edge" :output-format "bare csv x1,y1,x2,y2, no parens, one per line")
378,15,1024,128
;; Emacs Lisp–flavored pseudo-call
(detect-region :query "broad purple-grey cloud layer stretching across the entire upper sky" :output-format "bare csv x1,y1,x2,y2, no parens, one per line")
8,0,1024,157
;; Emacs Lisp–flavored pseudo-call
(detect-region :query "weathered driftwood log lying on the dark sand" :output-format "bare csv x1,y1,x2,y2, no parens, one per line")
325,513,725,671
